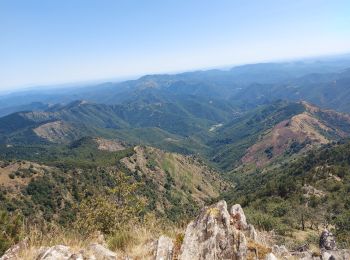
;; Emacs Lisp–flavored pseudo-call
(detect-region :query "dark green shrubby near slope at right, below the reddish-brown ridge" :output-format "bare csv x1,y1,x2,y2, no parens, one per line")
225,140,350,247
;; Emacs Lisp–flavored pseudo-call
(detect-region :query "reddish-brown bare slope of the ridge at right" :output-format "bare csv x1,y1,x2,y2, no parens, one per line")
242,102,350,166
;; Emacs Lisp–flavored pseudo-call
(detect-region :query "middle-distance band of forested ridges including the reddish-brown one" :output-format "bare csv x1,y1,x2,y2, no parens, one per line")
0,98,350,173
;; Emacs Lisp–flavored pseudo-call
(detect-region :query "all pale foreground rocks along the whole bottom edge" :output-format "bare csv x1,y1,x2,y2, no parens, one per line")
0,201,350,260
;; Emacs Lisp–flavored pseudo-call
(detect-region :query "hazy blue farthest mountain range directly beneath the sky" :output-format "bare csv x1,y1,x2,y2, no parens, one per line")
0,55,350,115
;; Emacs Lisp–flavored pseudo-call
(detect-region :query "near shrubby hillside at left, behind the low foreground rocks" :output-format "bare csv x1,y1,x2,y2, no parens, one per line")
0,138,221,255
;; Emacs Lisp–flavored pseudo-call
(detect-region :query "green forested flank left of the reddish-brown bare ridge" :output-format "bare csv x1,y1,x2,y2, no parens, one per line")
208,101,305,170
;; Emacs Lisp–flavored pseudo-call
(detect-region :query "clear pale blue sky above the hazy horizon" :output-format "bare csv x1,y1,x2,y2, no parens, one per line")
0,0,350,90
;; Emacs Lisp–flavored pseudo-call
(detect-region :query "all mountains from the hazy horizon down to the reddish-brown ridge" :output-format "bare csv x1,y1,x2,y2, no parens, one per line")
0,56,350,170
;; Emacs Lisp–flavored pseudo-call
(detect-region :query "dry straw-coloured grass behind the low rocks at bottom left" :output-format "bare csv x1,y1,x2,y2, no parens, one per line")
13,215,183,260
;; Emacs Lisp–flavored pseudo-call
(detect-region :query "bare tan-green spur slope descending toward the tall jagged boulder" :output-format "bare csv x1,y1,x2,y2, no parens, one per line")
121,146,228,214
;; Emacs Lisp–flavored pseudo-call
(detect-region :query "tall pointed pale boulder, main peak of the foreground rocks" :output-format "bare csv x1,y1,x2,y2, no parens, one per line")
179,201,247,260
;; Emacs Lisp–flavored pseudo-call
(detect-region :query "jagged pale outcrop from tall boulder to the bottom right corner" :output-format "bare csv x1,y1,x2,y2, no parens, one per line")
178,201,350,260
